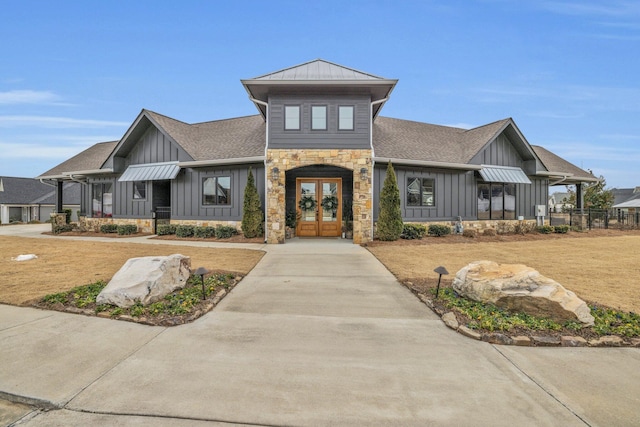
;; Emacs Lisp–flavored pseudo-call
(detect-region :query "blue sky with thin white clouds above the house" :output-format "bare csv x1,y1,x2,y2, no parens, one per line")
0,0,640,188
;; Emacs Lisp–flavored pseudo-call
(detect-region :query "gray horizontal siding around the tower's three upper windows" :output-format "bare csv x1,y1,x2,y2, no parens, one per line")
269,95,371,149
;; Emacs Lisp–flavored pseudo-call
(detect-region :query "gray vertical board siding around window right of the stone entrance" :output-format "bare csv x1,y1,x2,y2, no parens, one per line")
373,165,477,222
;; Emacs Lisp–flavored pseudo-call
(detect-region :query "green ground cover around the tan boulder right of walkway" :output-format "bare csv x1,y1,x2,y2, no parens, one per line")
432,288,640,337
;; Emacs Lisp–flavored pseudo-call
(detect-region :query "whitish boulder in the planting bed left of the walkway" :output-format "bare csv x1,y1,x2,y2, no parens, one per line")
96,254,191,308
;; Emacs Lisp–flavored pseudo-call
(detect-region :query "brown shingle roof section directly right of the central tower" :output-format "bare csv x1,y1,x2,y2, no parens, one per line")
373,117,510,164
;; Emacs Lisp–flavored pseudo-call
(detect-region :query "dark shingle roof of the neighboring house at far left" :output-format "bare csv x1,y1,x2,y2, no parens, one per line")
0,176,80,205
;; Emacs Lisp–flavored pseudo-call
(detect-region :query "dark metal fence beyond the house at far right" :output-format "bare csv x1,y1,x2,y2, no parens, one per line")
549,209,640,230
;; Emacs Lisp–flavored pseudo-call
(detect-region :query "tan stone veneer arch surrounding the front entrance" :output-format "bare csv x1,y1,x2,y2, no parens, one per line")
266,149,373,244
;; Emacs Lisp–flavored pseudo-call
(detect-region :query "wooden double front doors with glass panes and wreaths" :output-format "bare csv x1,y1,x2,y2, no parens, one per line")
296,178,342,237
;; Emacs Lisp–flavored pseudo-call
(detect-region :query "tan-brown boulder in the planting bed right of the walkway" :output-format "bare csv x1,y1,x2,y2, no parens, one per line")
453,261,594,326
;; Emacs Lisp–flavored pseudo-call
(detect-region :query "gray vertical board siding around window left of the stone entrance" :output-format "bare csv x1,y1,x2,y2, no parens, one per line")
171,163,265,221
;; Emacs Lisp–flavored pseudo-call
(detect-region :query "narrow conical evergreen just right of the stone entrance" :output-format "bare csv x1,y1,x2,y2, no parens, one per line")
377,162,403,241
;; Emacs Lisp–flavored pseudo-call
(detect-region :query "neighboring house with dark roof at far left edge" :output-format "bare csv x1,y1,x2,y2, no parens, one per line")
0,176,80,224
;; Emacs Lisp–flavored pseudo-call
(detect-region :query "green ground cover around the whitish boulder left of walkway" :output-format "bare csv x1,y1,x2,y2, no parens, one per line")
41,274,235,317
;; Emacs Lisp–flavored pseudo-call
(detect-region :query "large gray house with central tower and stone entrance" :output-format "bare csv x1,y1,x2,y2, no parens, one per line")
38,59,597,243
